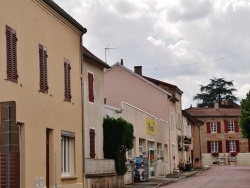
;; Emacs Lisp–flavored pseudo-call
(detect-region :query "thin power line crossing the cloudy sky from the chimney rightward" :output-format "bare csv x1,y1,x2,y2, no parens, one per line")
143,51,250,70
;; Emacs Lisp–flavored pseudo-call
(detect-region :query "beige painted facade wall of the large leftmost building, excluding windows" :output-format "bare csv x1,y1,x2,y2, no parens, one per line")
0,0,82,188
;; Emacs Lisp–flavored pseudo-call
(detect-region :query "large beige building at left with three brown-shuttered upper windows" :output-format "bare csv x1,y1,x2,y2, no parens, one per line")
0,0,87,188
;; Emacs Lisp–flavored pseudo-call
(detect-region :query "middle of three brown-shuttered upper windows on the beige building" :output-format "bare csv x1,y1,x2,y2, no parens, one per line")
39,44,49,93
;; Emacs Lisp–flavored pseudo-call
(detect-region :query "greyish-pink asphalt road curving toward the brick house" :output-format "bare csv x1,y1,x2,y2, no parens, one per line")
162,165,250,188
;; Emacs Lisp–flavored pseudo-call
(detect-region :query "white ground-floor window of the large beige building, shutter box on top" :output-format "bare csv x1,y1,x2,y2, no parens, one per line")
61,131,75,177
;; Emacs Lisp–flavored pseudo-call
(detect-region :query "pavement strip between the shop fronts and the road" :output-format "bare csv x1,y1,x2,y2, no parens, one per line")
125,168,207,188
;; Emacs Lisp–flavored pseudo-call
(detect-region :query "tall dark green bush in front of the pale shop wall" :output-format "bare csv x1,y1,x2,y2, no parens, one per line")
103,117,134,175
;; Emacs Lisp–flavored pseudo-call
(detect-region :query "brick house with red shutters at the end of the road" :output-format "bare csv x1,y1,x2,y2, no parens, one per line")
185,101,250,166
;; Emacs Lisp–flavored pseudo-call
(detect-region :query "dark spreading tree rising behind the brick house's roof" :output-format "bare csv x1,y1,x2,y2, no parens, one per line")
193,78,238,107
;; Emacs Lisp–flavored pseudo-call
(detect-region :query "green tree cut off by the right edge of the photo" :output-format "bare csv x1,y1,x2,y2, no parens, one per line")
240,91,250,140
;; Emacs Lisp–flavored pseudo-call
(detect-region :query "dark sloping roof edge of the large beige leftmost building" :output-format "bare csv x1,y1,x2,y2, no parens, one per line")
43,0,87,34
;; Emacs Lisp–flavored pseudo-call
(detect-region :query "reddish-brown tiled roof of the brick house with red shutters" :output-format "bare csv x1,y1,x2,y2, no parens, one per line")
185,107,241,117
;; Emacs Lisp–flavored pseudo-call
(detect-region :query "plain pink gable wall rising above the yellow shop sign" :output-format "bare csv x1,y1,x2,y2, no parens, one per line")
104,64,169,121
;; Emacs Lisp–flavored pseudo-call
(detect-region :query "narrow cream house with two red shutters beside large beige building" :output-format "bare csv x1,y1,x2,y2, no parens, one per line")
82,47,117,188
